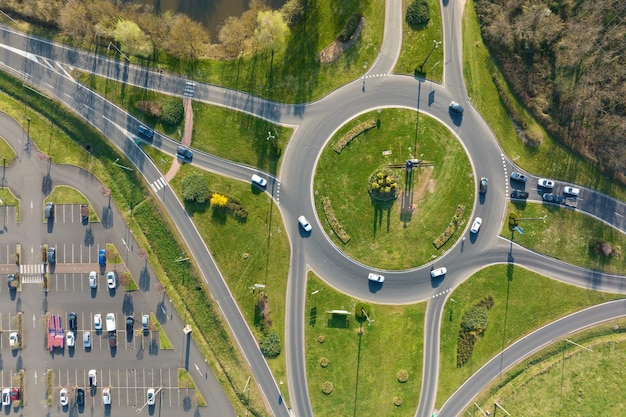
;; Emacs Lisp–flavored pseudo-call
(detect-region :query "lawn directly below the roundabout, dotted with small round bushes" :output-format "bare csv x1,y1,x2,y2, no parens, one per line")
305,272,426,417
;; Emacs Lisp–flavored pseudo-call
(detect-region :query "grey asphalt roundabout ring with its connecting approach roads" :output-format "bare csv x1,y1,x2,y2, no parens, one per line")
0,0,626,416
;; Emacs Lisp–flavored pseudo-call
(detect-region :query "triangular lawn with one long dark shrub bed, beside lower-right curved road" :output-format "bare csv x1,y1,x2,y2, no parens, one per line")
436,264,623,407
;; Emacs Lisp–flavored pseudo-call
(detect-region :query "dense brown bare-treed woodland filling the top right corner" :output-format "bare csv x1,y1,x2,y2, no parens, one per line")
475,0,626,183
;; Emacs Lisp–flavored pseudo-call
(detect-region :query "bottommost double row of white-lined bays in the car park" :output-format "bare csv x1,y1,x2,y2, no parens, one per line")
52,368,182,409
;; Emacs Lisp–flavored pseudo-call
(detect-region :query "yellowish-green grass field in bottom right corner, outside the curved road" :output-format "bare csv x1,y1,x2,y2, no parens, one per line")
463,319,626,417
